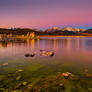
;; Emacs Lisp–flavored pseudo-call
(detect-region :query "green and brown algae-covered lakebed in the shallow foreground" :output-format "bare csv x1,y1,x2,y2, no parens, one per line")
0,67,92,92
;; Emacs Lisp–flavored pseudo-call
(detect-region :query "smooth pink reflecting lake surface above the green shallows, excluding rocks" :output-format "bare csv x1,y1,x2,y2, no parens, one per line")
0,37,92,71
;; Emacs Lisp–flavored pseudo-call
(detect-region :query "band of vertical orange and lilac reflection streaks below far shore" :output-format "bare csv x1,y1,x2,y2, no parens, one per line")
0,37,92,51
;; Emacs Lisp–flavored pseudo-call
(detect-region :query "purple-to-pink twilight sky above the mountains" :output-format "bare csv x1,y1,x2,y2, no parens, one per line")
0,0,92,28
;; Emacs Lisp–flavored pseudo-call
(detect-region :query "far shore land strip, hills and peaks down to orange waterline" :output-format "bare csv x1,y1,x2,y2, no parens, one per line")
0,28,92,37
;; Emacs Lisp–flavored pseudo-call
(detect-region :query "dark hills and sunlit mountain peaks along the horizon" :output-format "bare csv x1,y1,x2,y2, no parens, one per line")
0,27,92,35
